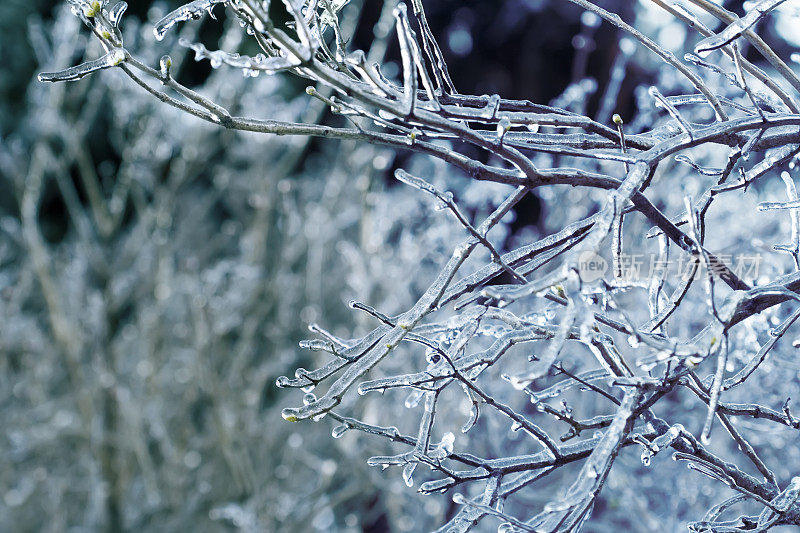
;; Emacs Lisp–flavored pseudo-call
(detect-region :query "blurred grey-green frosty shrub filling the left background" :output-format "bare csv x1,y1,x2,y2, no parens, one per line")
0,6,476,531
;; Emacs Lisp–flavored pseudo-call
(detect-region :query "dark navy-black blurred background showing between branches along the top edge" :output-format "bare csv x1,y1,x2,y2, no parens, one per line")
0,0,785,135
